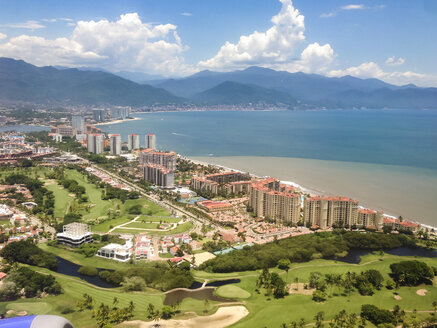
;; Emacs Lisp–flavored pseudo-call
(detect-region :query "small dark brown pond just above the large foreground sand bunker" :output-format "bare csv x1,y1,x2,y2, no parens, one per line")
164,279,241,305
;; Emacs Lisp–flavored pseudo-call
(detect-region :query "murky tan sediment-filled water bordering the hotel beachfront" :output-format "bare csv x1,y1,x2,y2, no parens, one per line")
190,156,437,227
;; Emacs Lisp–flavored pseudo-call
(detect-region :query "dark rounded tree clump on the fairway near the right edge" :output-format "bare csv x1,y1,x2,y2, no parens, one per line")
390,261,434,286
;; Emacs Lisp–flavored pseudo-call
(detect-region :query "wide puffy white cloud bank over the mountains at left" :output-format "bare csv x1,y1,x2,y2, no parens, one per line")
0,13,192,74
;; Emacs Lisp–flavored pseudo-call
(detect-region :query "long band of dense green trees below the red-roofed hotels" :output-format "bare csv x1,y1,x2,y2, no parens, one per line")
200,231,415,272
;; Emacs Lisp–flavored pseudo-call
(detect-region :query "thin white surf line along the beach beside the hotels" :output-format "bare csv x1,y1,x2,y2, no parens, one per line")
187,156,437,231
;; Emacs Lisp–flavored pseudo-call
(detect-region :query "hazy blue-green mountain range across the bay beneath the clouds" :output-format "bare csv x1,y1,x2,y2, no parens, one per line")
0,58,437,108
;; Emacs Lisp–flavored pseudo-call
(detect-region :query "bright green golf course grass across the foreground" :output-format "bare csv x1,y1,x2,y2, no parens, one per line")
0,252,437,328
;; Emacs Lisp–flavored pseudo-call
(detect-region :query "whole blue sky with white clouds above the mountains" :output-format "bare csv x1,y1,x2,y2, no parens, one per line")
0,0,437,87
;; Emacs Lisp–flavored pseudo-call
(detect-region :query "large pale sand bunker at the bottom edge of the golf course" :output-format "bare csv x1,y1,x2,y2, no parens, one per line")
119,306,249,328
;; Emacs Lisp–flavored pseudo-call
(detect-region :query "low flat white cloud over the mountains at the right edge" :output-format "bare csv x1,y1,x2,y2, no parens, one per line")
327,62,437,86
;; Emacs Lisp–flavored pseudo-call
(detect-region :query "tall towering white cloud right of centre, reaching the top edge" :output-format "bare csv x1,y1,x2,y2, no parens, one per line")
198,0,334,72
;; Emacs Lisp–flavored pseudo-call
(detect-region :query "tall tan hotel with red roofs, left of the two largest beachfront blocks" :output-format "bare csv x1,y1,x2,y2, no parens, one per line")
249,178,300,223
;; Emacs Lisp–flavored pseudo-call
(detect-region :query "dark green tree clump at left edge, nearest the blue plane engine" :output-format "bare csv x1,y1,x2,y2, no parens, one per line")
0,267,62,301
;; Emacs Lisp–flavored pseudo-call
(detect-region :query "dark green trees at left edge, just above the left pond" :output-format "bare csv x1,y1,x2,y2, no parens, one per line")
0,239,58,271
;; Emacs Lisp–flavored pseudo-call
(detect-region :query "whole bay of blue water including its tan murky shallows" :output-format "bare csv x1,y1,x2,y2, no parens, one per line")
101,110,437,226
